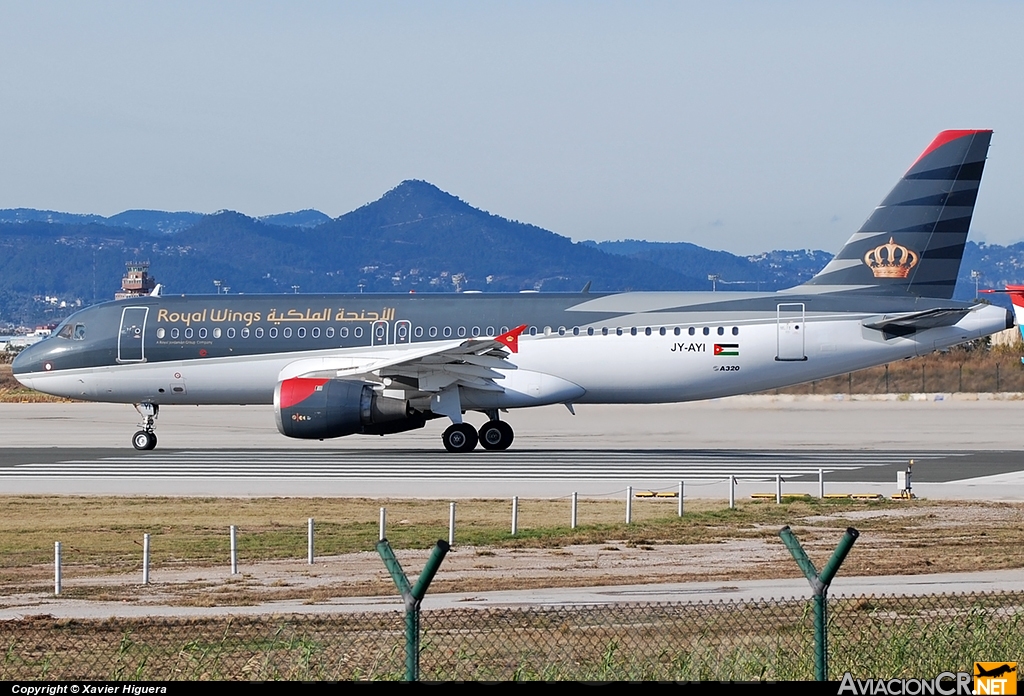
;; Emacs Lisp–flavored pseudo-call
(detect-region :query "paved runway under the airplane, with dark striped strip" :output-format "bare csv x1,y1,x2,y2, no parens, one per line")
0,396,1024,501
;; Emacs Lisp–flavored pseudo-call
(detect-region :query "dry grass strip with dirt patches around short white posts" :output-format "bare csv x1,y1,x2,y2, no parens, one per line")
0,496,1024,606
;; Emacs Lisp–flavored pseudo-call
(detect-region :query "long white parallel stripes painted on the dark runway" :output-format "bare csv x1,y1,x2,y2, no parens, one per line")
0,450,958,480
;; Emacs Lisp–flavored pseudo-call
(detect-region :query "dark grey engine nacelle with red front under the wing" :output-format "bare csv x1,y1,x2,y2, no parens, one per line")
273,377,426,440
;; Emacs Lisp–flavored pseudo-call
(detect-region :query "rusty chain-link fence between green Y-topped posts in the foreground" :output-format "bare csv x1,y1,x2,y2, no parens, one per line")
0,593,1024,681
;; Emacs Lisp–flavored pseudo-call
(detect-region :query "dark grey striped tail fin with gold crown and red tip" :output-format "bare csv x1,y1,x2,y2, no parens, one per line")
793,130,992,300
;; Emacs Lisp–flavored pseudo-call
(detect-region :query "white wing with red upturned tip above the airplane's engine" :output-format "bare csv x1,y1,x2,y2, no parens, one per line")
278,324,526,392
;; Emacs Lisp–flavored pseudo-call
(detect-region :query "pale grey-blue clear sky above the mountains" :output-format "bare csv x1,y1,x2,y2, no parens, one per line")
0,0,1024,254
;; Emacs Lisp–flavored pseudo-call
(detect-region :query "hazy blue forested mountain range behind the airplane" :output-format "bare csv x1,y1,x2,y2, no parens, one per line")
0,180,1024,324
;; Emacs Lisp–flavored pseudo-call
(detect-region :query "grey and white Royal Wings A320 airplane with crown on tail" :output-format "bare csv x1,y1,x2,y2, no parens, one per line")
13,130,1014,452
